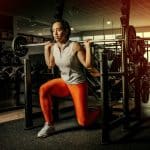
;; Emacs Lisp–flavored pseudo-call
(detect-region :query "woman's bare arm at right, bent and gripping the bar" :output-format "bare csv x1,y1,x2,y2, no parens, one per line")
74,40,92,68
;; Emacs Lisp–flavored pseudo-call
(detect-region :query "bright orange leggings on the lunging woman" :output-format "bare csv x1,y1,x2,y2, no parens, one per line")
39,78,100,126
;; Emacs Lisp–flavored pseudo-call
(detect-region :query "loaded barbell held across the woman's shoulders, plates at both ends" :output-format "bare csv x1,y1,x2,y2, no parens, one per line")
12,26,145,61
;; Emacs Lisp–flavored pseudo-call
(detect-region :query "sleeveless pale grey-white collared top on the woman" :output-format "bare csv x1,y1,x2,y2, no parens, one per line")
51,41,86,84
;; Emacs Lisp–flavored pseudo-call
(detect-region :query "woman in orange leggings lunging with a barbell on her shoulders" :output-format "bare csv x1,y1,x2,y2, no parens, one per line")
37,20,100,137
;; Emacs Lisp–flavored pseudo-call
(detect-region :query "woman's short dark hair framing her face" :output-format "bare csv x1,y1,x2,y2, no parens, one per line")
50,19,71,39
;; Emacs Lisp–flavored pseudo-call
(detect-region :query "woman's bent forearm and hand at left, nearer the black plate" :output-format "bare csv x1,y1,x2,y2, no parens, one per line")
44,42,55,69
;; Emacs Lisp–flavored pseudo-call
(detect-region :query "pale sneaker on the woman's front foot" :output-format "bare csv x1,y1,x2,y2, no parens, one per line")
37,123,55,138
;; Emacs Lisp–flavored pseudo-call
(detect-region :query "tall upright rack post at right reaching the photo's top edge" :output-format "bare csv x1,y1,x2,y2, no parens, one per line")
122,0,130,129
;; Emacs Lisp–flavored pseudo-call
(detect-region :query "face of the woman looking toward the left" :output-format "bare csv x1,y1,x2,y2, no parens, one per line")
52,22,66,42
